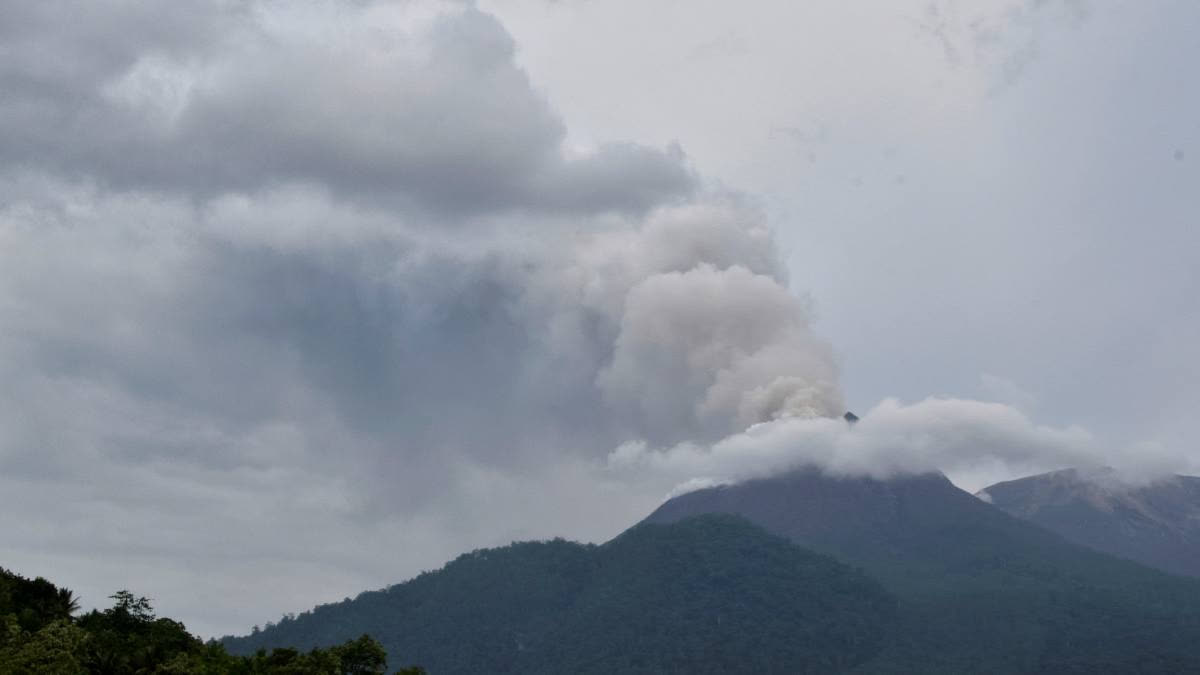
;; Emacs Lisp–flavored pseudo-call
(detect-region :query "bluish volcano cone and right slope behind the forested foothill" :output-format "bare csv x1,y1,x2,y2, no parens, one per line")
646,470,1200,673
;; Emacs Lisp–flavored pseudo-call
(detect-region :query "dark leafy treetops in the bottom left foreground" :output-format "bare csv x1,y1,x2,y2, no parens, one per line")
0,569,422,675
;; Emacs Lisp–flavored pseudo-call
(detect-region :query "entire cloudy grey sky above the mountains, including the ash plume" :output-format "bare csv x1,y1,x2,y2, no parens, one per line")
0,0,1200,637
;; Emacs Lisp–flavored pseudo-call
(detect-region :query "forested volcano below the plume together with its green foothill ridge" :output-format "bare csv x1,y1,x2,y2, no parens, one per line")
223,470,1200,674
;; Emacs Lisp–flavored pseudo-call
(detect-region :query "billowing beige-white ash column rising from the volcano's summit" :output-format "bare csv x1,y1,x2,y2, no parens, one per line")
535,199,842,443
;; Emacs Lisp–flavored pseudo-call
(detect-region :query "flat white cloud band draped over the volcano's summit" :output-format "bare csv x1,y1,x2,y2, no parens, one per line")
607,398,1192,495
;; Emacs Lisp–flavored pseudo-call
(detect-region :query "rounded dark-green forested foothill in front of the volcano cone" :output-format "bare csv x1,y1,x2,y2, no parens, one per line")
224,515,895,674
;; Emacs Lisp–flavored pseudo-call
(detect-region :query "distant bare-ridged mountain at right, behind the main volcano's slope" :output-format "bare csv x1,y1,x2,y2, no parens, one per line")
977,468,1200,577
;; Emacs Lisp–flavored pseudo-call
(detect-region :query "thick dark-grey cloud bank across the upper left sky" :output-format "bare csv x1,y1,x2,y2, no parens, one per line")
0,2,694,216
